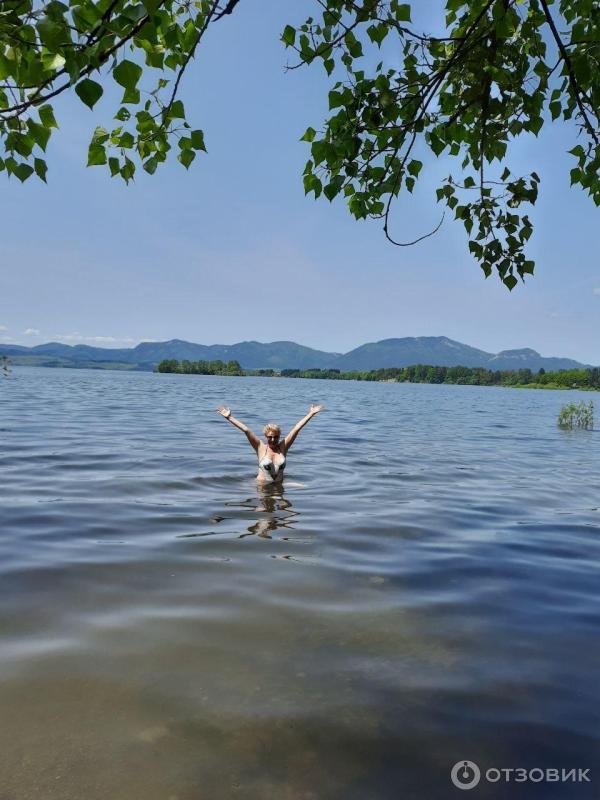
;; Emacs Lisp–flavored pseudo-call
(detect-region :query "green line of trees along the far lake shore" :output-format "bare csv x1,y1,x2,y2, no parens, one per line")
158,359,600,389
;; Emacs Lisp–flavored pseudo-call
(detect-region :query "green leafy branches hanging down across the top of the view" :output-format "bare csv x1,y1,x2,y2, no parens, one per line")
0,0,600,289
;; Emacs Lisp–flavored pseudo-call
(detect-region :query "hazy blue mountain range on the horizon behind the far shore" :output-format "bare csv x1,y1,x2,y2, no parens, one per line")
0,336,588,372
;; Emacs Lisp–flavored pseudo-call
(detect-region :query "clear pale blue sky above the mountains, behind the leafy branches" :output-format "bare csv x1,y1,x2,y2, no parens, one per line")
0,0,600,364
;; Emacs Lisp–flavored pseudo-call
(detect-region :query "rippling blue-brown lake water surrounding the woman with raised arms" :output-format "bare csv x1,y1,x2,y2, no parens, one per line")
0,368,600,800
